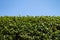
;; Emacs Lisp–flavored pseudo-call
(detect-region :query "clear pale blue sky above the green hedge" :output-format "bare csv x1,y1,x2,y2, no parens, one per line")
0,0,60,16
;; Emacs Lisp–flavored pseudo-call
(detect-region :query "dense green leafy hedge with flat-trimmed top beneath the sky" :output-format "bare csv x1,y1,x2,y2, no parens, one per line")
0,16,60,40
